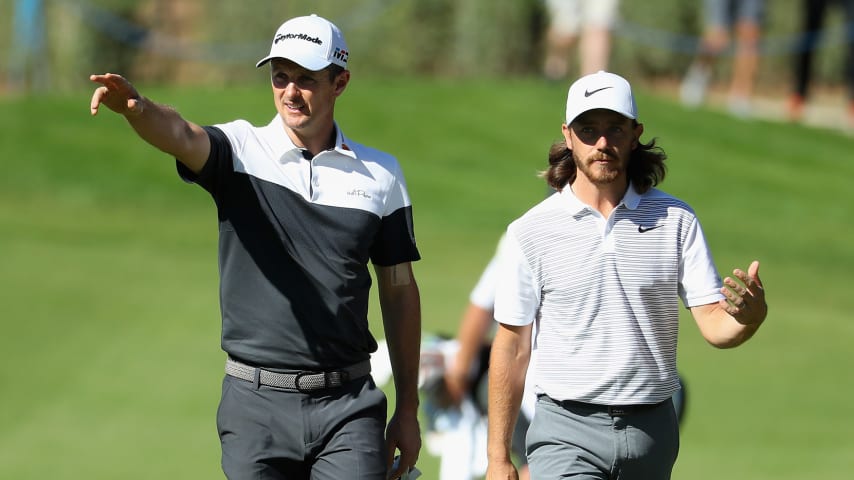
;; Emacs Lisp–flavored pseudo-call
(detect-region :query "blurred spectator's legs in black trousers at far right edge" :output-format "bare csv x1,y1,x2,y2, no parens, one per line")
788,0,854,126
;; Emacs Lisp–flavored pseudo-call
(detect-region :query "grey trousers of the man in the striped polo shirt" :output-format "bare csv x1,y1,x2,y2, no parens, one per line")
527,395,679,480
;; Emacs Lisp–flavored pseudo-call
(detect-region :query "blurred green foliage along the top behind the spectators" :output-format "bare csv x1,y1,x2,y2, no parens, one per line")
0,0,850,93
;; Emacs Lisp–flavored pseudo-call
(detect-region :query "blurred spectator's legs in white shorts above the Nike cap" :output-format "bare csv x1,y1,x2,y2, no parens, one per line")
543,0,620,80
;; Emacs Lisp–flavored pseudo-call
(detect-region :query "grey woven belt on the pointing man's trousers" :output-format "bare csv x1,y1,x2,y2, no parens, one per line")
225,357,371,392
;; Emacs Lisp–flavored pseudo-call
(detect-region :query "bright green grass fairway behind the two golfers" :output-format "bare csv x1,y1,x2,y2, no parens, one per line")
0,78,854,480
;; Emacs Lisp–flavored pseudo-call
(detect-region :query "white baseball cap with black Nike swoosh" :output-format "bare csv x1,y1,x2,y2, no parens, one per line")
566,70,638,125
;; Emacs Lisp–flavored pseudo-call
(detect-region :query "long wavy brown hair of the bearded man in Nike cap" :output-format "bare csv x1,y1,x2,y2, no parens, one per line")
540,130,667,193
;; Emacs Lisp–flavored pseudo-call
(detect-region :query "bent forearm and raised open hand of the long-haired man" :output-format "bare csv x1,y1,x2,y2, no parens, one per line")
691,261,768,348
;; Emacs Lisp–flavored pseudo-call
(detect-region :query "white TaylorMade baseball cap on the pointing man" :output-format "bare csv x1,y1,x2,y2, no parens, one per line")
255,14,350,72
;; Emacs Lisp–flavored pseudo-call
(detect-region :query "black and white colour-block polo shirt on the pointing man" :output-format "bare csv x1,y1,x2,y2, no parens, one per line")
178,116,420,370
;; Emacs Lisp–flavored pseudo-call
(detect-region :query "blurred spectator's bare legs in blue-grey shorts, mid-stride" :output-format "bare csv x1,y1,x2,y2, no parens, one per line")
679,0,765,117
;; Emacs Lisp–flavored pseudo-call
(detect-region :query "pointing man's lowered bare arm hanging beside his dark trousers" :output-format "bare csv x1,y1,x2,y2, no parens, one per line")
376,263,421,478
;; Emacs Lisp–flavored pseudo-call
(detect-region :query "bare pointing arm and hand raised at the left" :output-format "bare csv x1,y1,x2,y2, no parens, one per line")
89,73,210,173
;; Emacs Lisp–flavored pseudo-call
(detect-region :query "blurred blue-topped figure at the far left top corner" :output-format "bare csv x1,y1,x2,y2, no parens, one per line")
9,0,48,90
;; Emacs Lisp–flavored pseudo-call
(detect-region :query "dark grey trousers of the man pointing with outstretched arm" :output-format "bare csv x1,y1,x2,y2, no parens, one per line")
217,375,386,480
